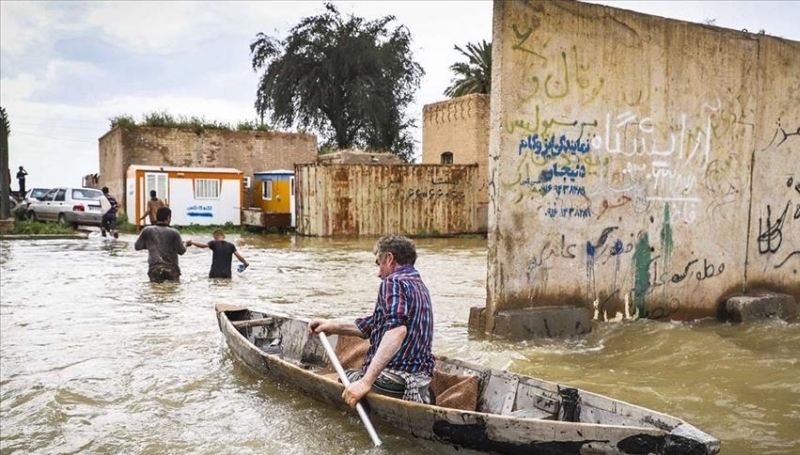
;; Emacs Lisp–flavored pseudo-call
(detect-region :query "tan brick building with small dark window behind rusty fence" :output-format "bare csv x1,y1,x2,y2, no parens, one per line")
422,94,490,231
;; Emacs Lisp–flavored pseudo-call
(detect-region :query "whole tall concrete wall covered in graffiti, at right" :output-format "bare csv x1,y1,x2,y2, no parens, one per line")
486,1,800,331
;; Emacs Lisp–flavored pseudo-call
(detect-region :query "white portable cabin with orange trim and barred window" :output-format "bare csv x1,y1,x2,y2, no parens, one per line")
125,165,244,226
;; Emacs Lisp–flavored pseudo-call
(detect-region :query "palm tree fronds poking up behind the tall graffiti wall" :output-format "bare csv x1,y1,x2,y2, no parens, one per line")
444,40,492,98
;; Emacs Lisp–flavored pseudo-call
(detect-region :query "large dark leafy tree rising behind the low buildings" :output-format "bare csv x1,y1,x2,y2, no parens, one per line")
250,4,424,161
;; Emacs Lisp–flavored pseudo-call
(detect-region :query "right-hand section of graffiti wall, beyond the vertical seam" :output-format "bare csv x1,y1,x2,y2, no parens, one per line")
738,37,800,302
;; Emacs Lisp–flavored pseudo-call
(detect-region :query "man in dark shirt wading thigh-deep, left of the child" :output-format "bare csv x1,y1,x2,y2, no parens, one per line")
138,207,186,283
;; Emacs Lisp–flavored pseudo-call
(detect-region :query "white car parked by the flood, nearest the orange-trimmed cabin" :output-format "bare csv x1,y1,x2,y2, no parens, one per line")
25,188,103,227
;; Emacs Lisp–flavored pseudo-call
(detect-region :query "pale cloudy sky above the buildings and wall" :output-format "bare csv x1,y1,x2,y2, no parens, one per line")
0,0,800,190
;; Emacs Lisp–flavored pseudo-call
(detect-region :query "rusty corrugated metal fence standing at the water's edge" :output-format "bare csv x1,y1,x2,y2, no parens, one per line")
295,163,478,237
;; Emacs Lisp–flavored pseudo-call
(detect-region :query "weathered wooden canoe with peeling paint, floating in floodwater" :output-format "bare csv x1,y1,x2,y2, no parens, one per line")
216,304,720,455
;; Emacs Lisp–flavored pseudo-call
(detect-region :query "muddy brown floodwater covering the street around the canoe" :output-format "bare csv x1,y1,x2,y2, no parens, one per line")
0,235,800,455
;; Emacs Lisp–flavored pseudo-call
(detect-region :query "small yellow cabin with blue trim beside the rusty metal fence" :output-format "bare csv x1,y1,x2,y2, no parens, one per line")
253,169,295,227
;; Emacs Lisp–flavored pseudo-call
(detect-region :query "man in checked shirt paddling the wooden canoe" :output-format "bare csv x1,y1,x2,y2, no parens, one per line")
308,235,435,407
